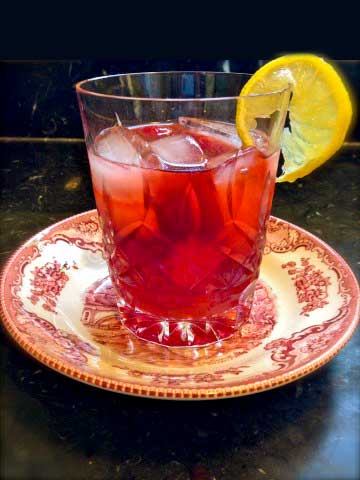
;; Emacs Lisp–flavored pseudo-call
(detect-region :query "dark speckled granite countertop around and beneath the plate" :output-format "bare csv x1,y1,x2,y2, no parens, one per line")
0,142,360,480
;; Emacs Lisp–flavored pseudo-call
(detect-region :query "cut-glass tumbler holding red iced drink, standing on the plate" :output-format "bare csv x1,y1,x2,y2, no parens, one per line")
76,72,290,347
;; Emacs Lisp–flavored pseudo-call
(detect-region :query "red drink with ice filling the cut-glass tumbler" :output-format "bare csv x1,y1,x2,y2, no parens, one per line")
89,120,278,346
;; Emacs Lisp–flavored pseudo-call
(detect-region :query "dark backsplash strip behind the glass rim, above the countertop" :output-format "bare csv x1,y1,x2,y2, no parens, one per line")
0,58,360,141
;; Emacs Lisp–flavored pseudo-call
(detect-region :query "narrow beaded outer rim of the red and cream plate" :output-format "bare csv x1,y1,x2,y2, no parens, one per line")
0,209,360,400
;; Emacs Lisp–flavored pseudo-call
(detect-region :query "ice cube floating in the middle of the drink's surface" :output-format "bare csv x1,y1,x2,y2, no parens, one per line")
151,135,207,169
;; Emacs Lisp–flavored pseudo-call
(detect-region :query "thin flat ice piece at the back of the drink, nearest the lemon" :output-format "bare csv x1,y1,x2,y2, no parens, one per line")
178,117,242,148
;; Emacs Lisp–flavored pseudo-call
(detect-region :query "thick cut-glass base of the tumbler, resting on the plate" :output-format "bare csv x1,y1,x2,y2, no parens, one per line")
118,304,251,347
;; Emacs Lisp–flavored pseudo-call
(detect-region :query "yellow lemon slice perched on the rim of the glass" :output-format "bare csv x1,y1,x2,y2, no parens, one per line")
236,54,352,182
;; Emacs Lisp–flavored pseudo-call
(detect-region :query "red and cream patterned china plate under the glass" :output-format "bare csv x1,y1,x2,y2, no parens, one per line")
1,210,359,399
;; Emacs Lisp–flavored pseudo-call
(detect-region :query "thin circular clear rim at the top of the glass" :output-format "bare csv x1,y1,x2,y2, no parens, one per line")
75,70,291,102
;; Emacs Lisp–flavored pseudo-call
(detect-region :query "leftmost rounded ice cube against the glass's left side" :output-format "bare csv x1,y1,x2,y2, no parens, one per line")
95,126,148,166
